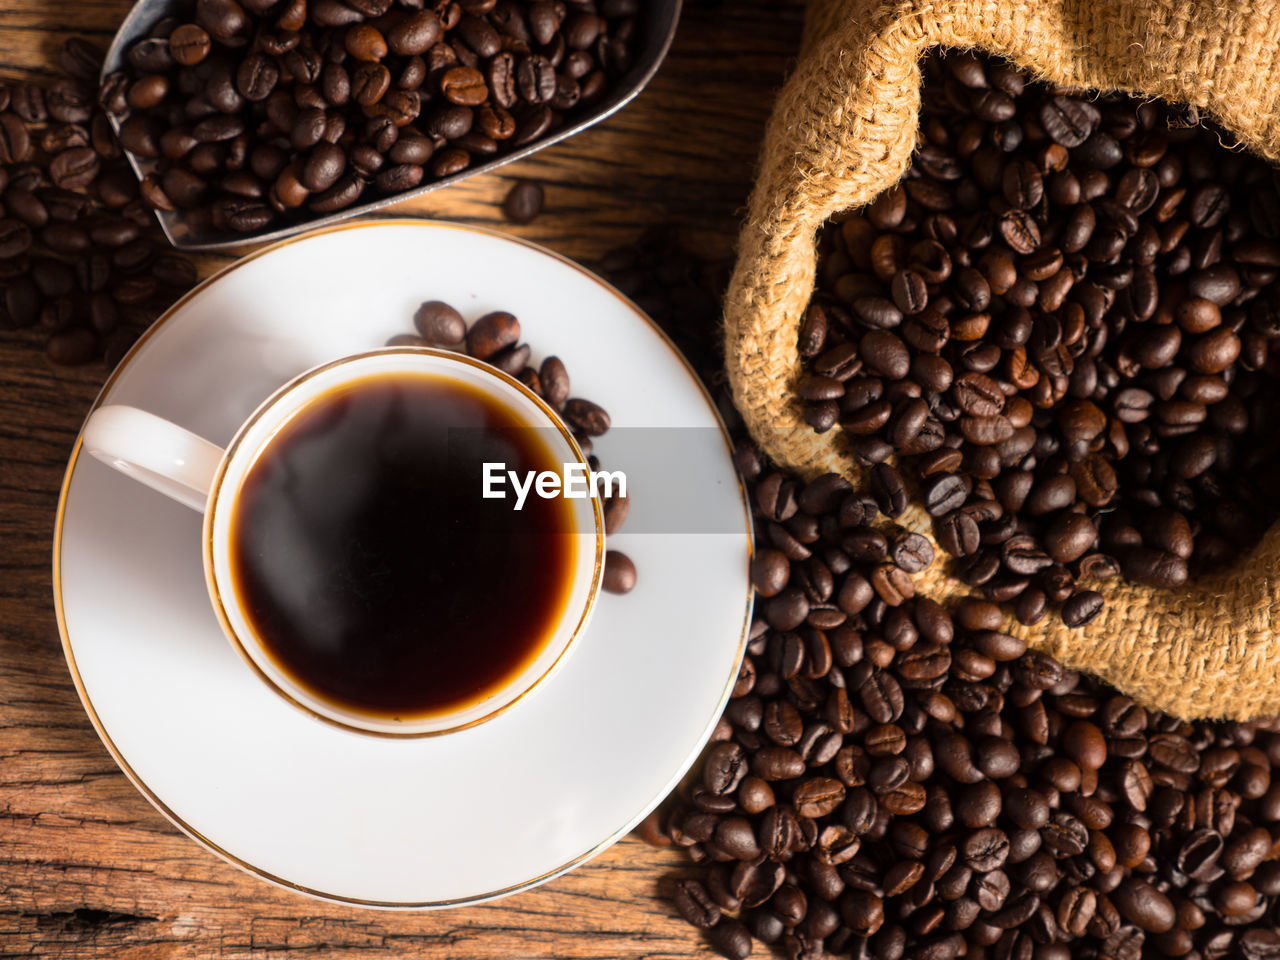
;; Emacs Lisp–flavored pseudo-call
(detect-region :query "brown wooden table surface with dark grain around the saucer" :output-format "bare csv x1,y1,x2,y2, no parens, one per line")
0,0,801,960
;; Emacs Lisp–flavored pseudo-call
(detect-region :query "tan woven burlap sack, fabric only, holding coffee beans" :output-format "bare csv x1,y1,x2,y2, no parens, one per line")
724,0,1280,719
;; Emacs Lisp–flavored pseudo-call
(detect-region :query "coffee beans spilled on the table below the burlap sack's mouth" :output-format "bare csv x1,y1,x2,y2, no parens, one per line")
649,455,1280,960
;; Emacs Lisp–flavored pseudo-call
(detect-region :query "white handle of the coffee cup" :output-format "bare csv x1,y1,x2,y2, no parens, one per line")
82,404,223,513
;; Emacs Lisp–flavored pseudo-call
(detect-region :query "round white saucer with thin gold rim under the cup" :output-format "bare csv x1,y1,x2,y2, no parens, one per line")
54,220,750,908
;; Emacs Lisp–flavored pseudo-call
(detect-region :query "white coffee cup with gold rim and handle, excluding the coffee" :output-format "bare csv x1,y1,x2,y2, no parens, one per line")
83,347,604,736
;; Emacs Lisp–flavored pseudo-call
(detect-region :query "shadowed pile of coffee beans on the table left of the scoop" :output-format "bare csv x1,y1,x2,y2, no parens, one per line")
0,38,196,366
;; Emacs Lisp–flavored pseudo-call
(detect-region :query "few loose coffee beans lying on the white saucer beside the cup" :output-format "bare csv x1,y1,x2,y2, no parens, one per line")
387,300,636,594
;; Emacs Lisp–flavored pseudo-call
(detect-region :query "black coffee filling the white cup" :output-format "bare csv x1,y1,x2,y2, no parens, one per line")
230,374,576,718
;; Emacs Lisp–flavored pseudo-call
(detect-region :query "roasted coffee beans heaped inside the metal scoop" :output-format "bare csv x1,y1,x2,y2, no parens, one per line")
101,0,639,233
